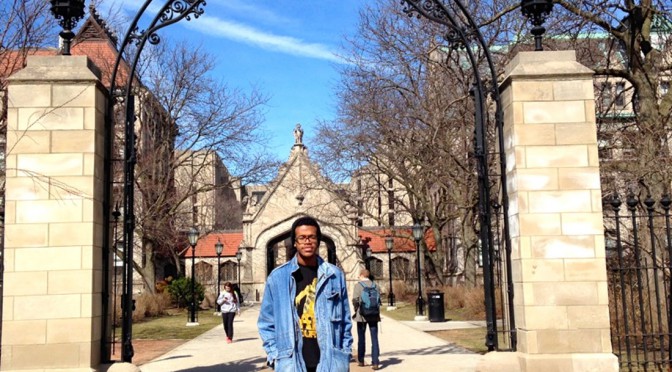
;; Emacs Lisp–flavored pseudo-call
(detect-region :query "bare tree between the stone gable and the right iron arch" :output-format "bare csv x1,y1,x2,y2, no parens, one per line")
318,0,488,284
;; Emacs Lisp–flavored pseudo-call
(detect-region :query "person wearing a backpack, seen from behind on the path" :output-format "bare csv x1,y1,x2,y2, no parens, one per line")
352,269,381,370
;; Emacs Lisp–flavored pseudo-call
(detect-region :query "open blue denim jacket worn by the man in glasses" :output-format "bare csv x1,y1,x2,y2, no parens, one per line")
257,256,352,372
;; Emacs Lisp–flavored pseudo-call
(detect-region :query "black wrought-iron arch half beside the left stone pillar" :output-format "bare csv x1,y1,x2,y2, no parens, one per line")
101,0,205,363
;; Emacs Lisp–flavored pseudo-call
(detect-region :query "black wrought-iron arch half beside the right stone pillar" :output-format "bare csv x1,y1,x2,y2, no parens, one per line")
402,0,517,351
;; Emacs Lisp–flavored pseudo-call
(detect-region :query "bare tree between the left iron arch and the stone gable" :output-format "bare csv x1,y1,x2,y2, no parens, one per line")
122,43,276,288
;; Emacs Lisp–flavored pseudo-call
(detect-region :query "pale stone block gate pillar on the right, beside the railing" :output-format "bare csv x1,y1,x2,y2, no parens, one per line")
490,51,618,372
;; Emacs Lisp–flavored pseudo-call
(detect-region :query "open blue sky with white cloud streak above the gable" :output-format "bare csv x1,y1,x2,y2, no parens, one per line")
101,0,363,159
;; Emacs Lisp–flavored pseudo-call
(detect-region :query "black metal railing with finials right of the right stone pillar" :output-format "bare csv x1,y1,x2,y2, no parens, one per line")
605,193,672,371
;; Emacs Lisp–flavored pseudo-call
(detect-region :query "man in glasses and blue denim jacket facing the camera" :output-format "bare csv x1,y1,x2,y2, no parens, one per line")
257,217,352,372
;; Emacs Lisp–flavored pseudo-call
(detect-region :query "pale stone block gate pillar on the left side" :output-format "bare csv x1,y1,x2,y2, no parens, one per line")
0,56,106,371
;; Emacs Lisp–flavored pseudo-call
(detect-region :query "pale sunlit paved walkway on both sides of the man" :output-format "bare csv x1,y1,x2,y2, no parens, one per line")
140,306,483,372
